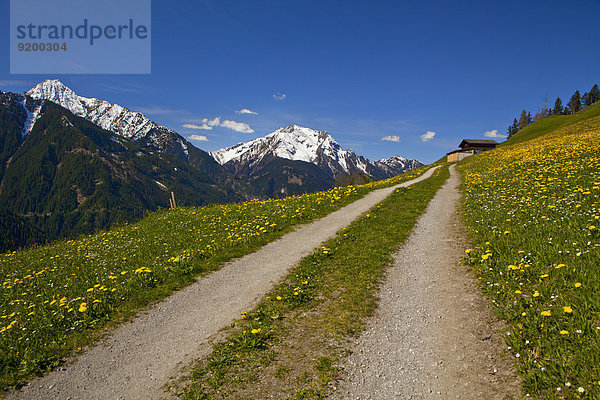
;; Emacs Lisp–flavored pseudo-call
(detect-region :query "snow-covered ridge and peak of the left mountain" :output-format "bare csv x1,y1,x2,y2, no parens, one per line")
25,79,188,155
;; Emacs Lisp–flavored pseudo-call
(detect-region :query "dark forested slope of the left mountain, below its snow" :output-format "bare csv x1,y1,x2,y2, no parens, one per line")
0,88,246,251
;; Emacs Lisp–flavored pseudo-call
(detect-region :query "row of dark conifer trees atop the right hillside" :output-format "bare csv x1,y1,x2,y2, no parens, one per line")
507,84,600,137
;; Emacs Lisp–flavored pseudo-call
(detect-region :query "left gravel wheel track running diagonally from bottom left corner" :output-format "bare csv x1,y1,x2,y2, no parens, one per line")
7,168,434,400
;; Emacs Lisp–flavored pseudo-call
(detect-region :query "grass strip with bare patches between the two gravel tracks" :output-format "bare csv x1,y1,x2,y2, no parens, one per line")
170,165,449,399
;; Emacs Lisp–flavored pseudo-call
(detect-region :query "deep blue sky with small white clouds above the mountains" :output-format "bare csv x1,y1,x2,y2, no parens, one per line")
0,0,600,162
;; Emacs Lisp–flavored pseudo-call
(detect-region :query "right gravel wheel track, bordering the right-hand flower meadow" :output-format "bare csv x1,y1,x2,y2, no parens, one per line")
332,167,520,399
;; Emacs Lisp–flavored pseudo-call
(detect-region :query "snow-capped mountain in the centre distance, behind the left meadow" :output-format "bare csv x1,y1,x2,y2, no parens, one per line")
210,125,423,195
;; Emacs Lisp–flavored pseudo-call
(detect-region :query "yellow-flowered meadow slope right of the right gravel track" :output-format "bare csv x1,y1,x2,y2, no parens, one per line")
461,117,600,399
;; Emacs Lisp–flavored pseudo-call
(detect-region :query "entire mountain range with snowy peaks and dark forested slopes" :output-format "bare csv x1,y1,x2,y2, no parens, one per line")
0,80,422,250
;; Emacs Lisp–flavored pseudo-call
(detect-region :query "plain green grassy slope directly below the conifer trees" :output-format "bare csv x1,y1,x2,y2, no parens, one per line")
501,102,600,146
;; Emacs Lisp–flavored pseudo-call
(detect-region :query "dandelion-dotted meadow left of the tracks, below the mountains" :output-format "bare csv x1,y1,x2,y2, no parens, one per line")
0,163,428,389
